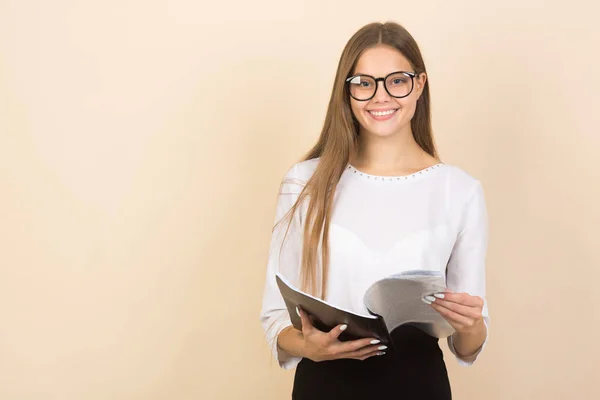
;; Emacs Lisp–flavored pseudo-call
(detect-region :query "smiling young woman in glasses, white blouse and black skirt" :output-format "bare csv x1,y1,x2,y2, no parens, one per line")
261,23,489,400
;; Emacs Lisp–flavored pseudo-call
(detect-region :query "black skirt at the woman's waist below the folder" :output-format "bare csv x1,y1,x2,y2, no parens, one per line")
292,326,452,400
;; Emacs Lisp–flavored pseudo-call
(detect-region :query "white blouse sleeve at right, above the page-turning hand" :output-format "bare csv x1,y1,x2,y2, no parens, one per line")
446,182,490,366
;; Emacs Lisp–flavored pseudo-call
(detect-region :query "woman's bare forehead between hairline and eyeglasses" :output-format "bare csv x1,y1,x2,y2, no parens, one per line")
353,45,412,77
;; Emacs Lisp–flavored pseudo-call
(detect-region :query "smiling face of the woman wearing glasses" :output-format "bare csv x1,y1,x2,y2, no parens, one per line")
350,45,427,137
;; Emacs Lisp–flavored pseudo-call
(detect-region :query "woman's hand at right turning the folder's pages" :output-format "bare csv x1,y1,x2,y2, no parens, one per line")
423,292,485,333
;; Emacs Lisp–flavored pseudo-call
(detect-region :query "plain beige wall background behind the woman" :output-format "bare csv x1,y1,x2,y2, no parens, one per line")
0,0,600,400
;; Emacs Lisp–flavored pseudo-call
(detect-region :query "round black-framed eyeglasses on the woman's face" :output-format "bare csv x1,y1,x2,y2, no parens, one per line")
346,71,416,101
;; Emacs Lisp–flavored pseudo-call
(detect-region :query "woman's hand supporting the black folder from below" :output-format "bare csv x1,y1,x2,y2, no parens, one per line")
298,309,387,362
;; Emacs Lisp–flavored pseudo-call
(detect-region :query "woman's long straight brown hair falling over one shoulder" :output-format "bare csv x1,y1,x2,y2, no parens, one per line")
280,22,437,298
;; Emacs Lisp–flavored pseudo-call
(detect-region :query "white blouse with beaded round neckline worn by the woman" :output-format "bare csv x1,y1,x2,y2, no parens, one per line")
260,158,489,369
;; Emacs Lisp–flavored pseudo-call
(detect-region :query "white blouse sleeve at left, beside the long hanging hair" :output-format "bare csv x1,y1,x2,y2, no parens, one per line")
260,165,304,369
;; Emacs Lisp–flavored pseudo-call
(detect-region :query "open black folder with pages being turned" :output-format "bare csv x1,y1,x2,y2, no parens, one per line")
276,270,454,347
